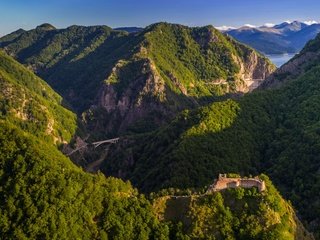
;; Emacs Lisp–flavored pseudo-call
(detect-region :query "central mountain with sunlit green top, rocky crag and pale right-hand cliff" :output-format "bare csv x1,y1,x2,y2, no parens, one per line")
84,23,275,135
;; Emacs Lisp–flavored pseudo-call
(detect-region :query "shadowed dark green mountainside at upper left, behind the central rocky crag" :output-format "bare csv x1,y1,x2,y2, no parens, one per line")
0,24,126,110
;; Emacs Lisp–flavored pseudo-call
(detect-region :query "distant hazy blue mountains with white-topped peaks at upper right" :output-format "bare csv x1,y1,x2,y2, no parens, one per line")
224,21,320,54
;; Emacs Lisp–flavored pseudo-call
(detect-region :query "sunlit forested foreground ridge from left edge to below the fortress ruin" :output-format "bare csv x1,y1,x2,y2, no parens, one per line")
0,52,312,240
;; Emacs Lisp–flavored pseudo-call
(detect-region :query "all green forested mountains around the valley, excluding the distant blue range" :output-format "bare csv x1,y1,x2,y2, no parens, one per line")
0,23,320,240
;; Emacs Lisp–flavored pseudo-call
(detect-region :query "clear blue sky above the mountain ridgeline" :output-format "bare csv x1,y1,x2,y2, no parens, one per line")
0,0,320,36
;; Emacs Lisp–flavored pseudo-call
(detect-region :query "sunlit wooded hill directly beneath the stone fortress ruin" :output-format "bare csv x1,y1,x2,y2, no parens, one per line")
153,176,313,240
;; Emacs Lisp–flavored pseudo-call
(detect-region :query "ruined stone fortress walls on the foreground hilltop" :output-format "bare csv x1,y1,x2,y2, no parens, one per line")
207,174,266,193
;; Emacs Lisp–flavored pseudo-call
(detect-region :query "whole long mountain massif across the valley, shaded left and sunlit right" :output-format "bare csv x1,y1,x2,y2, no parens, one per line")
0,23,275,138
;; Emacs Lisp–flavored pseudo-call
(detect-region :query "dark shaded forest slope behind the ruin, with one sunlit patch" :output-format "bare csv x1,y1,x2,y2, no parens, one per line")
102,31,320,238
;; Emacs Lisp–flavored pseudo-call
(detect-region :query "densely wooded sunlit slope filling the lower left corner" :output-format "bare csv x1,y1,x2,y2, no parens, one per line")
0,121,167,239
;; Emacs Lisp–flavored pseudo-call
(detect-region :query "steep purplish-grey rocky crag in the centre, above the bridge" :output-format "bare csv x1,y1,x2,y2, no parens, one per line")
86,59,172,134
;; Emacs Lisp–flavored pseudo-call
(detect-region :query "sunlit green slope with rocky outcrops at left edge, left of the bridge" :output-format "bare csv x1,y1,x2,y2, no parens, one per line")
0,51,76,143
